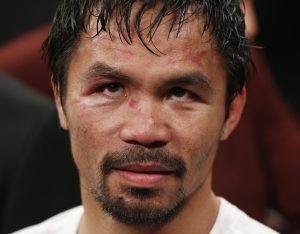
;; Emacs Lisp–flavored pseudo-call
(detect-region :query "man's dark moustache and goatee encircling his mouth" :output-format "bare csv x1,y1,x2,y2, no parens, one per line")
91,147,186,227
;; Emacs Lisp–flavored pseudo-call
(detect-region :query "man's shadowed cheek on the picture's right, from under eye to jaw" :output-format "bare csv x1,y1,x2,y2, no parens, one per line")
170,108,223,194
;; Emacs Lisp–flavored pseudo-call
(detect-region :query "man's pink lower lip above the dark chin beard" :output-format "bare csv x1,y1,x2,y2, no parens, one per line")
116,170,168,187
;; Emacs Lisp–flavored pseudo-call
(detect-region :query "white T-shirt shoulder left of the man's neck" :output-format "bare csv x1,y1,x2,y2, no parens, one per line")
12,206,83,234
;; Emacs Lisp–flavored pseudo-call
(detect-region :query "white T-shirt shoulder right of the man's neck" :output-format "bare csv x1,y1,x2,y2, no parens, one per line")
210,198,277,234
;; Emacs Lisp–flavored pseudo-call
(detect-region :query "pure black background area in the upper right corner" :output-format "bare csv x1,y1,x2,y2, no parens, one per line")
256,0,300,117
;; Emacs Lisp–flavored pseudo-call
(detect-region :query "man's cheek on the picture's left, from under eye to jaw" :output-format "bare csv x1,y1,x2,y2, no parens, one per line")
68,104,118,185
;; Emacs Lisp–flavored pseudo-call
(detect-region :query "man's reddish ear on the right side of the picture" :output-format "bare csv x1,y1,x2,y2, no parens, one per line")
221,87,247,140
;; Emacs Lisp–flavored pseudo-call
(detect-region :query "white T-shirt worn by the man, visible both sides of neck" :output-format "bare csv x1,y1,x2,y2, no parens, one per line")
13,197,277,234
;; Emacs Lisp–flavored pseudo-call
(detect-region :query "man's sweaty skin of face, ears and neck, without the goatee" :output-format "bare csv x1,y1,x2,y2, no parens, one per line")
56,10,246,234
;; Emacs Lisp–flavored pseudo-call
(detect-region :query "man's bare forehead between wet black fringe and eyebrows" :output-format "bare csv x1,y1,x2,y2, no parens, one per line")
75,15,218,66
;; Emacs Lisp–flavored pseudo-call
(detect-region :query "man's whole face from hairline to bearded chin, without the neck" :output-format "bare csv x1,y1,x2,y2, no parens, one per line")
56,12,245,225
